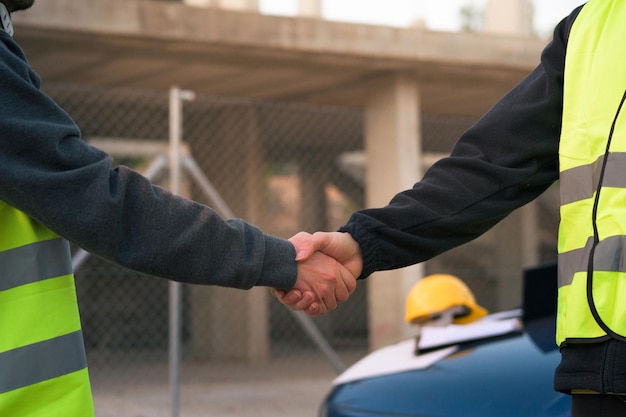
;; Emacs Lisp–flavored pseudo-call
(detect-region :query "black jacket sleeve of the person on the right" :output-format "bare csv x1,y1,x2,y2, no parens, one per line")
340,9,579,277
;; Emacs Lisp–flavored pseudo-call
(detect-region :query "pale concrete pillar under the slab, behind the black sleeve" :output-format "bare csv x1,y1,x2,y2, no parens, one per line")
365,75,423,349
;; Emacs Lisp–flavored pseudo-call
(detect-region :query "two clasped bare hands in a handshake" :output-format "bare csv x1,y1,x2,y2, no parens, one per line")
270,232,363,316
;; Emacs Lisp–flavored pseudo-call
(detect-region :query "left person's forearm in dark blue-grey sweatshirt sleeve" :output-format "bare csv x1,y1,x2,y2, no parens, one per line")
3,137,296,288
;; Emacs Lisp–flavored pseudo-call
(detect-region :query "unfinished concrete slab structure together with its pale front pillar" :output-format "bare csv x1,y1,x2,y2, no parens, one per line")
14,0,545,348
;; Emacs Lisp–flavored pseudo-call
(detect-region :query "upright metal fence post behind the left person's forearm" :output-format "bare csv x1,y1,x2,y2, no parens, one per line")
169,87,193,417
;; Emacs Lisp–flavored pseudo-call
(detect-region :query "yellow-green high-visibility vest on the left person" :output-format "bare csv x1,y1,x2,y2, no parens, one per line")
0,201,94,417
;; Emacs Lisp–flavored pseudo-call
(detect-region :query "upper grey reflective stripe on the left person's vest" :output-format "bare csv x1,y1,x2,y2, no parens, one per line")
0,238,72,291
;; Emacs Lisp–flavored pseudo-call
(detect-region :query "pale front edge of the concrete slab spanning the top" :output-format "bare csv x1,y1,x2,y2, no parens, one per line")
14,0,543,68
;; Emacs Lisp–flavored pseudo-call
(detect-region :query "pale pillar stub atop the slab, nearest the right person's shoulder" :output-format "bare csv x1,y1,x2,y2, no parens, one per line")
485,0,533,36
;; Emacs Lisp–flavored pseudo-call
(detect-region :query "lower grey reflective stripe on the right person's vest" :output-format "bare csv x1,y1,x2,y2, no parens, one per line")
559,236,626,287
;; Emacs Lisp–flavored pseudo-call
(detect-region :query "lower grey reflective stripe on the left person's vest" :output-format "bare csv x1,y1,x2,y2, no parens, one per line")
0,330,87,394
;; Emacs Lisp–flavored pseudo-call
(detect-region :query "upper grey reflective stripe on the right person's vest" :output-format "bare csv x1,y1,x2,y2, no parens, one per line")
560,152,626,205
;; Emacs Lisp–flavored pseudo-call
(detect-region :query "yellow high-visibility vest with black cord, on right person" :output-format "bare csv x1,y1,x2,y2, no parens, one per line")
556,0,626,345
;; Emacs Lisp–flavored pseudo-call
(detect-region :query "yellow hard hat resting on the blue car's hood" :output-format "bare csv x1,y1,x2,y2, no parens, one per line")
405,274,487,324
